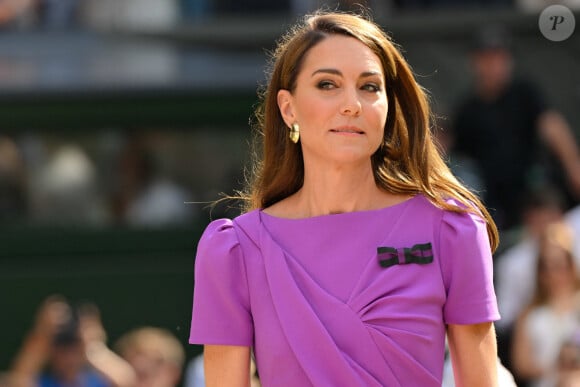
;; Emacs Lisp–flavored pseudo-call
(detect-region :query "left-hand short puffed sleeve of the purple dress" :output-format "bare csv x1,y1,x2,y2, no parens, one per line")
189,219,253,346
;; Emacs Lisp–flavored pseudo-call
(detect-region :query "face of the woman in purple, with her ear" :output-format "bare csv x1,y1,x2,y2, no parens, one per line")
278,35,388,165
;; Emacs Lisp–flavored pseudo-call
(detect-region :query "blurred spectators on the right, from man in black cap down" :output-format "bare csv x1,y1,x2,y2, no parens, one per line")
440,22,580,387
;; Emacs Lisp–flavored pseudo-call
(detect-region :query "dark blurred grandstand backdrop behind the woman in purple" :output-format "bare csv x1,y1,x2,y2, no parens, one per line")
0,0,580,383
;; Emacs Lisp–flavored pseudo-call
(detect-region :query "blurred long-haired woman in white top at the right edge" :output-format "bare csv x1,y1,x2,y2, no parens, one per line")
512,222,580,387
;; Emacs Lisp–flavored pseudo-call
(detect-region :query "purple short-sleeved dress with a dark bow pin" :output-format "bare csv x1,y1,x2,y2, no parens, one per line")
190,195,499,387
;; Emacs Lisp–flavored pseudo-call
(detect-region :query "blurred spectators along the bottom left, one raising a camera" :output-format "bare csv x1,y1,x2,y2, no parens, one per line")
0,295,259,387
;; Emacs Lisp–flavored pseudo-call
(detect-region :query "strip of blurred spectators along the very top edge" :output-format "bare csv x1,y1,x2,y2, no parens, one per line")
0,0,580,30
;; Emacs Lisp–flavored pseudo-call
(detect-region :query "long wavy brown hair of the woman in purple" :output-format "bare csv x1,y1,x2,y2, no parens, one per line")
242,11,499,250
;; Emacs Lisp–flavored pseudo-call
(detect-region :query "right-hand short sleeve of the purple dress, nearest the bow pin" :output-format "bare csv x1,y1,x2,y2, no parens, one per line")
439,211,499,324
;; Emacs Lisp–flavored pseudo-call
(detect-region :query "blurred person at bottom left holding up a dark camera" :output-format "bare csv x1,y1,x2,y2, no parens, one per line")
9,296,136,387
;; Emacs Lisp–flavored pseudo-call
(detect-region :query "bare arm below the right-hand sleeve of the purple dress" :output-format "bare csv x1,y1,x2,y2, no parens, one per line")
447,322,498,387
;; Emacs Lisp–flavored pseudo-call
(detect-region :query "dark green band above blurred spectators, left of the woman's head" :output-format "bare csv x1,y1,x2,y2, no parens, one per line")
0,90,256,132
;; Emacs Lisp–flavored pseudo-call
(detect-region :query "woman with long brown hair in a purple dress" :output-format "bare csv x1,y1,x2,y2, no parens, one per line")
190,13,499,387
